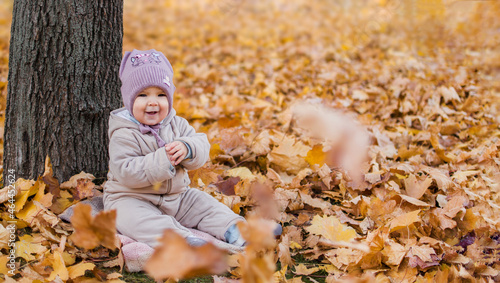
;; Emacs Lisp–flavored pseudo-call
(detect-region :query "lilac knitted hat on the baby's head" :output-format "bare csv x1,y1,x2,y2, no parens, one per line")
120,49,175,115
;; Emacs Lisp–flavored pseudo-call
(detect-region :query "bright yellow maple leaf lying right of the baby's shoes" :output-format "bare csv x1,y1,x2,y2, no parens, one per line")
306,215,357,242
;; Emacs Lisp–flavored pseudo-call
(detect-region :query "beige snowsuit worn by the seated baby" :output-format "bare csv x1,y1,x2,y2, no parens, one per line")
103,108,244,247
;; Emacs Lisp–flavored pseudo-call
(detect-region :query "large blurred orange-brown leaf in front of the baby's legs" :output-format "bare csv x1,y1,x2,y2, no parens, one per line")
144,230,227,280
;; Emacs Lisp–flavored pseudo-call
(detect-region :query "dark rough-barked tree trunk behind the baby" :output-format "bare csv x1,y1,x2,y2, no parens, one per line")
3,0,123,181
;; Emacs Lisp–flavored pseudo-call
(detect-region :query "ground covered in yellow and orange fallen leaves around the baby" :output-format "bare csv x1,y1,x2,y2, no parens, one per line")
0,0,500,282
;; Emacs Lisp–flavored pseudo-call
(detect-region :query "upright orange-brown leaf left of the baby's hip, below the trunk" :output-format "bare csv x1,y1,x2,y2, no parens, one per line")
70,204,116,250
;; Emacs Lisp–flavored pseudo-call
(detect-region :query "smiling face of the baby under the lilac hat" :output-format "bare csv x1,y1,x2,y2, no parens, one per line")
132,86,169,126
